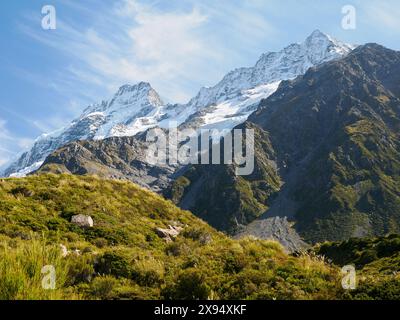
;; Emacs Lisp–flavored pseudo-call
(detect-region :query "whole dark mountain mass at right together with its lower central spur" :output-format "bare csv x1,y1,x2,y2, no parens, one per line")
170,44,400,242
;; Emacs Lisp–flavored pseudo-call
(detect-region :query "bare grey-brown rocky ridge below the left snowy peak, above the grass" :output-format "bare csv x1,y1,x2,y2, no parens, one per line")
37,137,176,192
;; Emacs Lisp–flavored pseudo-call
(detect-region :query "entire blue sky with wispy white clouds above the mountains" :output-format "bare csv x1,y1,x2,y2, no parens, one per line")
0,0,400,167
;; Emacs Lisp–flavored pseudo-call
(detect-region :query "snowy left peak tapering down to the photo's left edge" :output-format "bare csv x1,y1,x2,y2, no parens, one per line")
4,82,163,177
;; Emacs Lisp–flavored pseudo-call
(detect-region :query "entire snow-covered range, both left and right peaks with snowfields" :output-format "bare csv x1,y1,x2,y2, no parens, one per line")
4,30,355,176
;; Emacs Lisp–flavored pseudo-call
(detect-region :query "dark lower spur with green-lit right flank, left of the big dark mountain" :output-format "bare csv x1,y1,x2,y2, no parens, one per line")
164,123,281,234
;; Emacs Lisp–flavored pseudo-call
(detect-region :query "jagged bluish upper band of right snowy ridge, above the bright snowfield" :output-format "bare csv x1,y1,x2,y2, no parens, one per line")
184,30,355,112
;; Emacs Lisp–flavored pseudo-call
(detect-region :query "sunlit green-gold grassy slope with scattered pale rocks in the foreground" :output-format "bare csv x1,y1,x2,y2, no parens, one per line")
0,175,342,299
